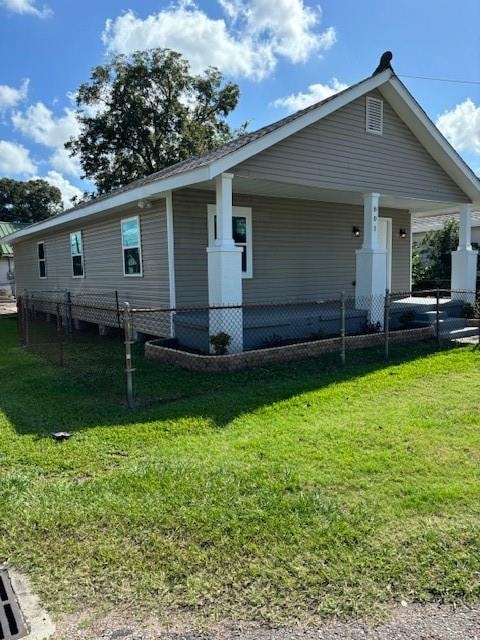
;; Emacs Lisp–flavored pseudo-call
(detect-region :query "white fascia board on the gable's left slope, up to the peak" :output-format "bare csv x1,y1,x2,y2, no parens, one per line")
210,69,393,178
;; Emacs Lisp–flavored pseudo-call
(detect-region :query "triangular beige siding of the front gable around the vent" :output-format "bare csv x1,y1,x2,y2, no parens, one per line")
231,91,468,202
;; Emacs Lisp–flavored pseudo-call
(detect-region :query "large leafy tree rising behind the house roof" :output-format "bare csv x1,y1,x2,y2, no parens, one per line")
66,49,239,193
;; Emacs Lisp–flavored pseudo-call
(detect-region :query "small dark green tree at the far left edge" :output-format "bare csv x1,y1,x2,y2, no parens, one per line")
0,178,63,223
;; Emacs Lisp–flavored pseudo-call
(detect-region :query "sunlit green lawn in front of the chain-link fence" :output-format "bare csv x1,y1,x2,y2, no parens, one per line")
0,319,480,621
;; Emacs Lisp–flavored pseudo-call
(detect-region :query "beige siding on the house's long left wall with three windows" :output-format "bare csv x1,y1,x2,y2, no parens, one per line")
15,201,170,307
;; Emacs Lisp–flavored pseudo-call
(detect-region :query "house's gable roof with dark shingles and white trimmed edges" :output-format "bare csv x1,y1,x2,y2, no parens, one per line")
3,69,480,241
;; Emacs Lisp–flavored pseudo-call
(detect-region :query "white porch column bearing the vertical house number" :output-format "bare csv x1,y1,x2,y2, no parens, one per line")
355,193,387,325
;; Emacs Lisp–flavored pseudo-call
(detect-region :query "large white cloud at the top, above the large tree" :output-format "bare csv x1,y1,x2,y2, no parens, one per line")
102,0,336,80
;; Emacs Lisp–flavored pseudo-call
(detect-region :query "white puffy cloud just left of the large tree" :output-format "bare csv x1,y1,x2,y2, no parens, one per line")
12,102,81,176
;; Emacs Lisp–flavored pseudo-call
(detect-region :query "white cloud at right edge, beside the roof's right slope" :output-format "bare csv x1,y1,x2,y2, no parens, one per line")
436,98,480,153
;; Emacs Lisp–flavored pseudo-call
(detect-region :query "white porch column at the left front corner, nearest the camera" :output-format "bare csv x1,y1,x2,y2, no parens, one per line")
207,173,243,353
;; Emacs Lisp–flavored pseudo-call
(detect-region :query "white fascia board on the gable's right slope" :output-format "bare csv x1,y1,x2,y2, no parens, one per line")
380,77,480,204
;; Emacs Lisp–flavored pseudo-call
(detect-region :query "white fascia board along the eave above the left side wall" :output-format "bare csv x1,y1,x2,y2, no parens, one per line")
2,166,208,243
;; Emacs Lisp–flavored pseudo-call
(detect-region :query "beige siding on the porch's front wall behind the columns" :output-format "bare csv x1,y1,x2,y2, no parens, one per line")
173,190,410,306
